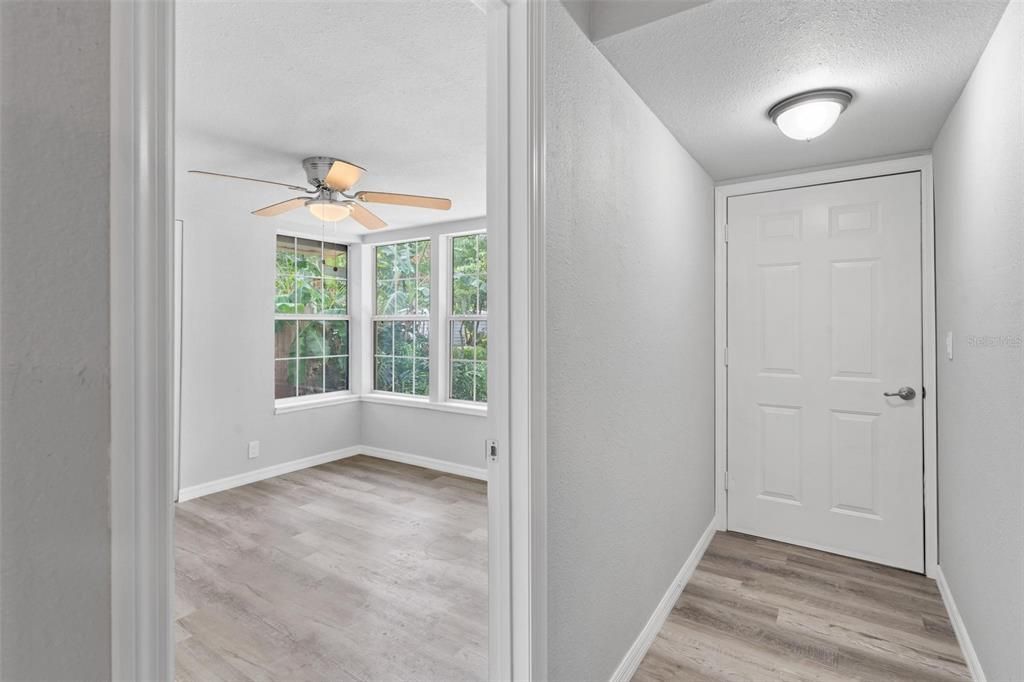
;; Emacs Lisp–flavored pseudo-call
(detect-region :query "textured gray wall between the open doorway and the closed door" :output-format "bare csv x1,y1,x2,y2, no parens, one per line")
545,3,715,680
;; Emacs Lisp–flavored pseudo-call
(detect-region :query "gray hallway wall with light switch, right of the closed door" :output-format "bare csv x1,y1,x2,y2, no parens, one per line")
934,2,1024,680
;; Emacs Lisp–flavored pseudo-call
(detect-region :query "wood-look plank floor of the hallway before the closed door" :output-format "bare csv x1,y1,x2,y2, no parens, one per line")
633,532,971,682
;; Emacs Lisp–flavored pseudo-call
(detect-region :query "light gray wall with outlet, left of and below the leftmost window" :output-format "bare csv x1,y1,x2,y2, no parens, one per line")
178,204,361,487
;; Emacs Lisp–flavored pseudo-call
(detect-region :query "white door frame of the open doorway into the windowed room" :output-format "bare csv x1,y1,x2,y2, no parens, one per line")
111,0,547,680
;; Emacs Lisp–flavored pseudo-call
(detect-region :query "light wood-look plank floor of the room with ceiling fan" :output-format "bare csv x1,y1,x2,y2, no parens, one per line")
174,456,487,682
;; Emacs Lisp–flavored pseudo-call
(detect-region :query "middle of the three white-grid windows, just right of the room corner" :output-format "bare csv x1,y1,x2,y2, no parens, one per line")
374,240,430,395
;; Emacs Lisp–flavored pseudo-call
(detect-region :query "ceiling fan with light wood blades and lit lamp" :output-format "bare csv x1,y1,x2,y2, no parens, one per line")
188,157,452,229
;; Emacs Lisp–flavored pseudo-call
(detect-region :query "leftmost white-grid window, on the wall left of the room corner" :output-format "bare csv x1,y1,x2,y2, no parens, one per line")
273,235,349,399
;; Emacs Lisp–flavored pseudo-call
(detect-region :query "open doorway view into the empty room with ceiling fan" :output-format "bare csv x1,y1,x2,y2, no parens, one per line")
173,0,499,679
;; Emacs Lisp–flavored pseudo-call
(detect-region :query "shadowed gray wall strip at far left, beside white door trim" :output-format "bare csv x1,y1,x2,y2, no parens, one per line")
0,0,111,680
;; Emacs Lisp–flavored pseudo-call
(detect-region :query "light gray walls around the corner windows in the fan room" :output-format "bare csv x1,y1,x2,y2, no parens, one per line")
178,208,487,488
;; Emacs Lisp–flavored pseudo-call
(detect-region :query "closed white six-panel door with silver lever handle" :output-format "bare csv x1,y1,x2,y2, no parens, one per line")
727,172,924,571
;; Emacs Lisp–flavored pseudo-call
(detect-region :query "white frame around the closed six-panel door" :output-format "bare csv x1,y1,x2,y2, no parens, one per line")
715,155,939,578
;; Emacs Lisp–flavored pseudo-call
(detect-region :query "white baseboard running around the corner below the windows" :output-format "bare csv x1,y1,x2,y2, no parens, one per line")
178,445,487,502
